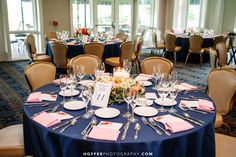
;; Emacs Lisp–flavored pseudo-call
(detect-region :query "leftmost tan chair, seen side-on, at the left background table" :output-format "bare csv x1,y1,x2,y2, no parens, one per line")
25,34,51,62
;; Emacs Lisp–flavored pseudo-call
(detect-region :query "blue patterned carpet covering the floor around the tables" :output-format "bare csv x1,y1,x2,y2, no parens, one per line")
0,52,236,137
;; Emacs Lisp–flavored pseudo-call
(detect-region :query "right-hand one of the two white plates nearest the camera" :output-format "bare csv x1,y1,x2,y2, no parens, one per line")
134,107,158,117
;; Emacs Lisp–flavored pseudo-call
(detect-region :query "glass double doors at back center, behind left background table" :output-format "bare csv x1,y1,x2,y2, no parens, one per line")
94,0,133,38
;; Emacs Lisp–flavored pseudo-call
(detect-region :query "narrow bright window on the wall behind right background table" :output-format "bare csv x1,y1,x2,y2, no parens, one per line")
187,0,201,27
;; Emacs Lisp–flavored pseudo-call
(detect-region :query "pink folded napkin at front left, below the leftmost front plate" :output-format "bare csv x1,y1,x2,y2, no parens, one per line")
33,112,61,128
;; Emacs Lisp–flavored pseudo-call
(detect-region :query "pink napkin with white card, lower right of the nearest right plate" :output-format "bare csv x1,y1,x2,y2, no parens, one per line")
154,114,194,133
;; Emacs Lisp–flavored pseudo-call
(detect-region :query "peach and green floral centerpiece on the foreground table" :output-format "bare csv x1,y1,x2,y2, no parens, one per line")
96,75,145,104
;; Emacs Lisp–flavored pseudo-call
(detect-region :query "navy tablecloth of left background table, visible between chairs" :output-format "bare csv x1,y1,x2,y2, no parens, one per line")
46,42,121,61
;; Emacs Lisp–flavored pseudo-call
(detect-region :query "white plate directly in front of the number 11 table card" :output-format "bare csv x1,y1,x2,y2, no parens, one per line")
95,107,120,118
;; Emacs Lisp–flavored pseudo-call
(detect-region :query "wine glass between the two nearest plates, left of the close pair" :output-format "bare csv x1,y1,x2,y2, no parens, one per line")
123,87,134,118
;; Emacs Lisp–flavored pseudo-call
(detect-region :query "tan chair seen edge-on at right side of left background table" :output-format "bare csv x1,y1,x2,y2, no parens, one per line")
131,36,143,72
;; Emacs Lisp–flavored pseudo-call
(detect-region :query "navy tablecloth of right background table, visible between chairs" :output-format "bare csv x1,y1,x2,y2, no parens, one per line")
167,37,214,63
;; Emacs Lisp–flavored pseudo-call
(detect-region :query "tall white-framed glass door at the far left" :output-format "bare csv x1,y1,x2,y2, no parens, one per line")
7,0,40,60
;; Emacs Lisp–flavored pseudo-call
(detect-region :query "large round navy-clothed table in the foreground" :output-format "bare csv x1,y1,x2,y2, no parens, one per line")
23,78,215,157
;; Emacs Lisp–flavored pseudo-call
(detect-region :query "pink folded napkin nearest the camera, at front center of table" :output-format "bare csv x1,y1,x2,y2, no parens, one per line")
88,126,120,141
